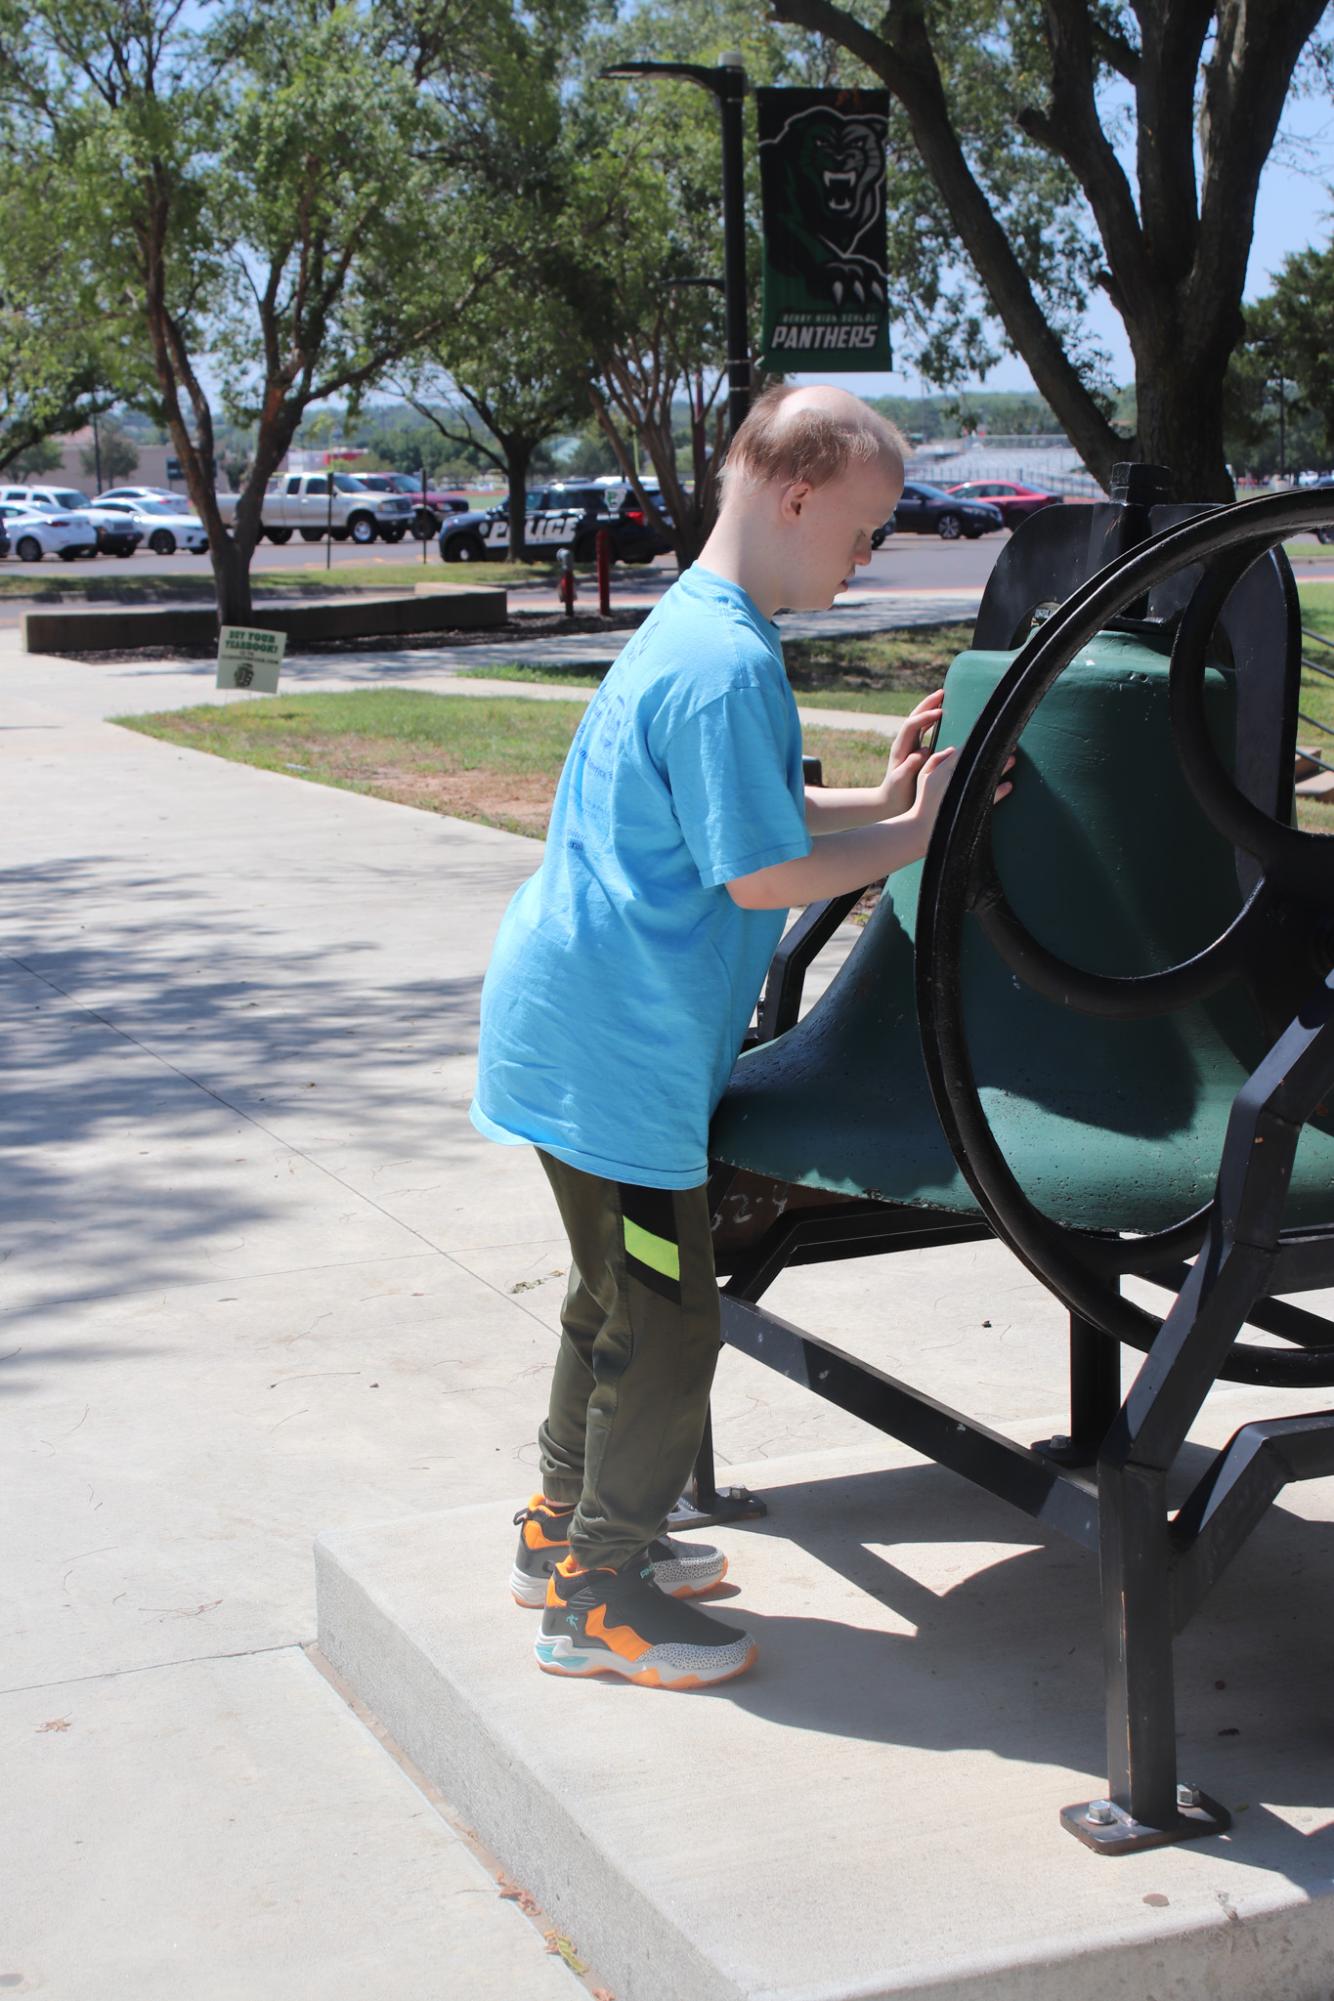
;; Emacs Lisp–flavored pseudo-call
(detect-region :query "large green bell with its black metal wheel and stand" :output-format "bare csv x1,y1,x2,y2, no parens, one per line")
696,468,1334,1853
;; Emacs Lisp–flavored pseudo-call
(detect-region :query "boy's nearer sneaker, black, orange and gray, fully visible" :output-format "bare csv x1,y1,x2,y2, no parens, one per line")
534,1553,756,1689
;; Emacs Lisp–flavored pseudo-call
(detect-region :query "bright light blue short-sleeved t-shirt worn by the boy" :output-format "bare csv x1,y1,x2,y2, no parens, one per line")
472,564,810,1189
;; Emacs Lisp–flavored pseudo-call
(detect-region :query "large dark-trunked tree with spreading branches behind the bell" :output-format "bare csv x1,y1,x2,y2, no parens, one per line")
770,0,1330,500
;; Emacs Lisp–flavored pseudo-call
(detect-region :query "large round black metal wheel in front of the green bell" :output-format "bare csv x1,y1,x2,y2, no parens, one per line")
916,492,1334,1387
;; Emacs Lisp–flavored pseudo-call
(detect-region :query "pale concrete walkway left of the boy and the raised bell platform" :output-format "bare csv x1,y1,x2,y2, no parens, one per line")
0,616,868,2001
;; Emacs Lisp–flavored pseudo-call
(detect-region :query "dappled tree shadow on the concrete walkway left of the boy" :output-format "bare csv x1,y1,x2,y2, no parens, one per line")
0,856,494,1336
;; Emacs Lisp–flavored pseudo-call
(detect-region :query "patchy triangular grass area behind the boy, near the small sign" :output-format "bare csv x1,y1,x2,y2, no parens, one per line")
116,688,888,838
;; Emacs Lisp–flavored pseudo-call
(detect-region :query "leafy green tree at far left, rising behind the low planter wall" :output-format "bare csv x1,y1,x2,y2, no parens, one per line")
0,0,576,620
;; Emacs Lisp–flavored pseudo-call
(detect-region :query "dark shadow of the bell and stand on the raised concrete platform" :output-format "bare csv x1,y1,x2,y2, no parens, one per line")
714,1447,1334,1895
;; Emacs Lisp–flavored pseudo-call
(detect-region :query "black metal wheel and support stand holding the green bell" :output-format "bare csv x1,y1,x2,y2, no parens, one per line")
708,488,1334,1855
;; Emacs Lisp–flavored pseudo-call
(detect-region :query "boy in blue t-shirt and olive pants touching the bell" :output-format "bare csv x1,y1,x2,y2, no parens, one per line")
472,388,976,1689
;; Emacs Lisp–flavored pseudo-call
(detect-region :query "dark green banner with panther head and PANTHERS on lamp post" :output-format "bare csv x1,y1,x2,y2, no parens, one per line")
756,90,892,374
